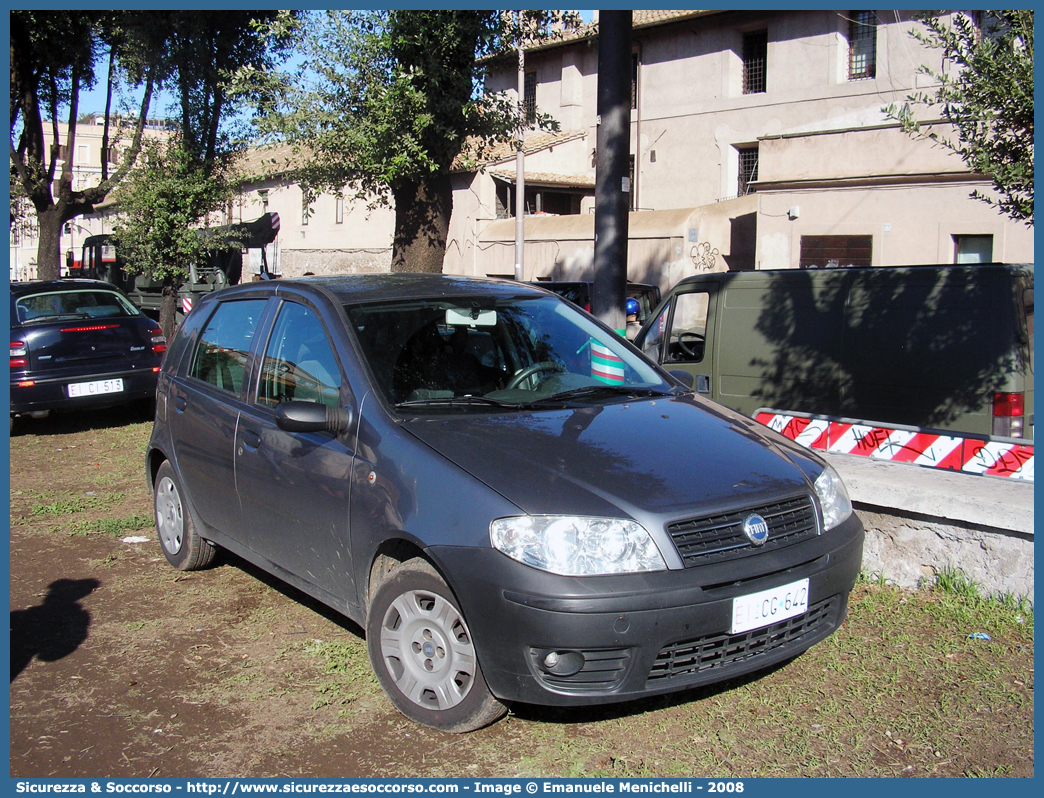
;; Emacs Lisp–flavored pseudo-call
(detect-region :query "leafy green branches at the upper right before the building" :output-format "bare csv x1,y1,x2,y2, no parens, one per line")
885,10,1034,227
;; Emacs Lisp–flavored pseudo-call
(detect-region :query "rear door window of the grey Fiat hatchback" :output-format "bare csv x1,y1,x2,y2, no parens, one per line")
189,300,265,394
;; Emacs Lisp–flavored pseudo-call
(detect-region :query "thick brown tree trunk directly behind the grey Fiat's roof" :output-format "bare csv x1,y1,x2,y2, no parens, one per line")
392,172,453,274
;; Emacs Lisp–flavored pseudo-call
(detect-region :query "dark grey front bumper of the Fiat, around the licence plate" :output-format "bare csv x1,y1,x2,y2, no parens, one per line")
429,514,863,706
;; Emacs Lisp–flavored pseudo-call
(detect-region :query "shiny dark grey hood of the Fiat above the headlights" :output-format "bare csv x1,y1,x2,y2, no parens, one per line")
404,395,812,524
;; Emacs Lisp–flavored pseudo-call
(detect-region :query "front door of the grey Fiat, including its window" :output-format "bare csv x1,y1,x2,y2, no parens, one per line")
235,298,356,604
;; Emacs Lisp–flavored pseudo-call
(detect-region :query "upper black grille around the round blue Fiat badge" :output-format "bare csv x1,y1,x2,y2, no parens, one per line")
667,495,818,568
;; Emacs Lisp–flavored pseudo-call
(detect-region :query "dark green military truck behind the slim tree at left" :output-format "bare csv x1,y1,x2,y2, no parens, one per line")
70,213,279,325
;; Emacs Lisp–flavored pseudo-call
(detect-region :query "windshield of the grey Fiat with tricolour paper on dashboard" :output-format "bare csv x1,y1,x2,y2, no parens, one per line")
345,297,672,412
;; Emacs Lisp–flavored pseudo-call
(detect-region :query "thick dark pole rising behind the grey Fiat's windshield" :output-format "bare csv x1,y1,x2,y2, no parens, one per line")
591,10,632,335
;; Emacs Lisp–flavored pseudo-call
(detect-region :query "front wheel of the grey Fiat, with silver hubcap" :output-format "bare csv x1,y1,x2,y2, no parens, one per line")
366,559,507,733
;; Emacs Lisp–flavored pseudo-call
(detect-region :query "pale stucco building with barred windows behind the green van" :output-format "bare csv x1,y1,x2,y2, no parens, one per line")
446,10,1034,287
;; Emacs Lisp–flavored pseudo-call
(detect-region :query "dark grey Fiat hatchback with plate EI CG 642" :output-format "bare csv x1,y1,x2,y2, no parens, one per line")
146,275,863,731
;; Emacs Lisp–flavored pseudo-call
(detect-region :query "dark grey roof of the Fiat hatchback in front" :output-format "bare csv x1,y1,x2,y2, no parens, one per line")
235,273,548,304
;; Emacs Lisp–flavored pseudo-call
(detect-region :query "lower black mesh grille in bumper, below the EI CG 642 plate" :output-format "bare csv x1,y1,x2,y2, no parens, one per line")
646,595,840,686
